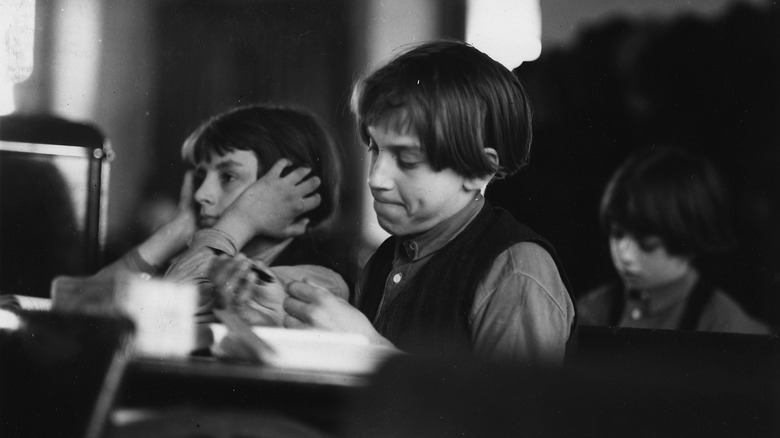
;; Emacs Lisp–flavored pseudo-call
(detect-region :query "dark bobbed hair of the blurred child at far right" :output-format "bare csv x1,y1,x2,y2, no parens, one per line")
600,147,735,259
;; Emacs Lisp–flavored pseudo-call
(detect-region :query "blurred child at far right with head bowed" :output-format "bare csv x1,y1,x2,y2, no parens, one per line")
578,147,769,333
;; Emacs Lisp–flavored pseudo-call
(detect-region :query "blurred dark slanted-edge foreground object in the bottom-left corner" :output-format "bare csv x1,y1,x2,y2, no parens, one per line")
0,310,133,438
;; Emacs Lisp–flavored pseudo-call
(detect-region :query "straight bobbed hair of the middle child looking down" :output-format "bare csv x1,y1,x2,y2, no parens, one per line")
352,41,531,178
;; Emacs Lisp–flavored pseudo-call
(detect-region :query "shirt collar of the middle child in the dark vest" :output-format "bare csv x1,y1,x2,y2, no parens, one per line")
395,193,485,261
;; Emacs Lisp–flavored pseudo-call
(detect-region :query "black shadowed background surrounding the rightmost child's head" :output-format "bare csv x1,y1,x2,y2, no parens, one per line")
487,0,780,327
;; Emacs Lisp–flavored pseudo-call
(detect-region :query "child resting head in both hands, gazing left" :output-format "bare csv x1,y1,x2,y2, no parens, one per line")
98,105,349,325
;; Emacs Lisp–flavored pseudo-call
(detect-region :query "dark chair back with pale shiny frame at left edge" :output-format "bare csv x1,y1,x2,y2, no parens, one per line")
0,115,113,297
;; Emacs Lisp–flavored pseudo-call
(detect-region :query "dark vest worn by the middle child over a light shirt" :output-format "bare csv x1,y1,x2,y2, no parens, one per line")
358,202,575,357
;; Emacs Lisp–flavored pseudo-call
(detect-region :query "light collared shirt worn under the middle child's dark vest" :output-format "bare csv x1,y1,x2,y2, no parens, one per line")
357,195,574,364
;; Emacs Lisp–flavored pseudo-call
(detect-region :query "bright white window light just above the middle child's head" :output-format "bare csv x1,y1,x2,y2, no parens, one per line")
466,0,542,70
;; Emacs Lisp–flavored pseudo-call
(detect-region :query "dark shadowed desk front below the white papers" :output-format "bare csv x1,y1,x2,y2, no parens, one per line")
116,357,371,434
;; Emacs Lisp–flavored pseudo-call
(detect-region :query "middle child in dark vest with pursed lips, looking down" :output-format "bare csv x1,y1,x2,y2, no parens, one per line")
274,41,575,364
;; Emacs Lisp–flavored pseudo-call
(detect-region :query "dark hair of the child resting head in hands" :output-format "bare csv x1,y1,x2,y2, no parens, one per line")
181,105,341,226
